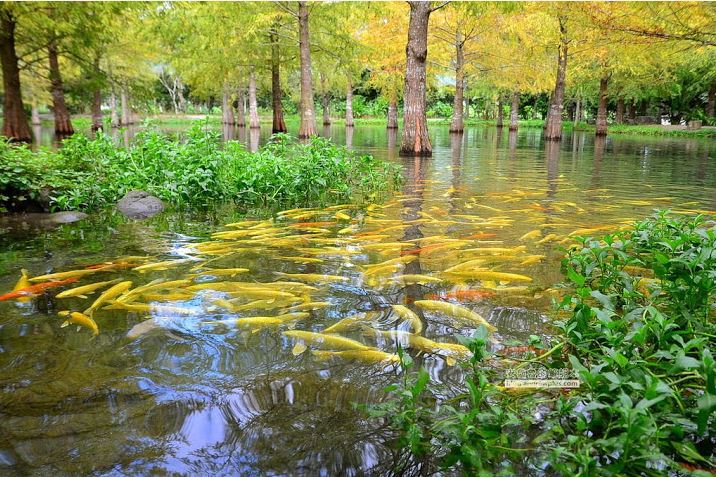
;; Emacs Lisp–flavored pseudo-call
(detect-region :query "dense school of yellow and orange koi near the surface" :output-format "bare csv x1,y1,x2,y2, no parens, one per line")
0,189,684,365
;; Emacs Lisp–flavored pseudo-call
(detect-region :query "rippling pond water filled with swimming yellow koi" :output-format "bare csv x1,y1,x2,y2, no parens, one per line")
0,126,716,475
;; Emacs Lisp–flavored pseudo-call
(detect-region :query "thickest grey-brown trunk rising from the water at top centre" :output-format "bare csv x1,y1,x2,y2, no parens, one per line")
400,1,433,156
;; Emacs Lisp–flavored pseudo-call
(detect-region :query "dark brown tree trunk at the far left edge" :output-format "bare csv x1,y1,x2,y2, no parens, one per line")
0,10,32,142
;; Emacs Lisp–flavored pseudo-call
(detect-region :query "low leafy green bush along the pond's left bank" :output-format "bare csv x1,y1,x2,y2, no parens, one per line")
0,126,400,214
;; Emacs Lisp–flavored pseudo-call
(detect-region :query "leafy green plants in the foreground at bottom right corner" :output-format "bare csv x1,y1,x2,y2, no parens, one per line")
372,213,716,476
